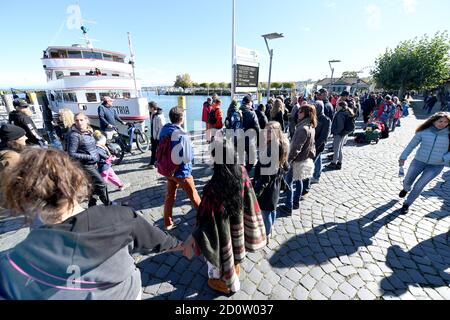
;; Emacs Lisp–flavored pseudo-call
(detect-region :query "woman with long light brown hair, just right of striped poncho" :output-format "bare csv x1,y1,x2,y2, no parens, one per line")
254,121,289,239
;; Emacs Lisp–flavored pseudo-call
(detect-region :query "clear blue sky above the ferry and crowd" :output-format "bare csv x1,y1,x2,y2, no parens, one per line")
0,0,450,87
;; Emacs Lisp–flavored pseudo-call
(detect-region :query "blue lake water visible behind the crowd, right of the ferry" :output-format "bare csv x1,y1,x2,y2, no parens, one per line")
143,92,266,131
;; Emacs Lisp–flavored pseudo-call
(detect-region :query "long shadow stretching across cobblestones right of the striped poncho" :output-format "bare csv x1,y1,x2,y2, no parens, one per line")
269,200,400,268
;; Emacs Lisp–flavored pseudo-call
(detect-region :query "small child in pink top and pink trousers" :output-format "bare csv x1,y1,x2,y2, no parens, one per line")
94,130,131,191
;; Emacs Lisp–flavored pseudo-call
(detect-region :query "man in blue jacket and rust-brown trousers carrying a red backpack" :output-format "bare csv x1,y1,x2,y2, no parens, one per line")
160,107,201,231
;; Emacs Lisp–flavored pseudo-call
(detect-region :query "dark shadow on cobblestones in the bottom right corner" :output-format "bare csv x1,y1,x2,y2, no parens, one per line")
380,232,450,296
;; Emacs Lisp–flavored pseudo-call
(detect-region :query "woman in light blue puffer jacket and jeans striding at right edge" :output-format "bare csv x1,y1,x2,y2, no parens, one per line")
399,112,450,214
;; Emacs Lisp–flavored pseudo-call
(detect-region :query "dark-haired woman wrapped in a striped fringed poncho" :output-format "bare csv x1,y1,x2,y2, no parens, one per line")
185,139,266,294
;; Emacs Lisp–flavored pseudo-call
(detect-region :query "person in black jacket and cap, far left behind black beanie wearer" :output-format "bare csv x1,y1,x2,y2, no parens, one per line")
8,100,48,146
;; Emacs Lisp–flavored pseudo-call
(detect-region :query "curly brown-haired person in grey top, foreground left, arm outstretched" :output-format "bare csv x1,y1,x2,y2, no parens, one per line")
0,148,192,300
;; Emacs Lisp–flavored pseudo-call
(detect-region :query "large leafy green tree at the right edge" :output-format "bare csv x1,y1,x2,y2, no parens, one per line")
372,32,450,96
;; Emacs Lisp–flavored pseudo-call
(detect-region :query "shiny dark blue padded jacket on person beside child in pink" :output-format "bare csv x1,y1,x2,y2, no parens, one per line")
68,125,100,165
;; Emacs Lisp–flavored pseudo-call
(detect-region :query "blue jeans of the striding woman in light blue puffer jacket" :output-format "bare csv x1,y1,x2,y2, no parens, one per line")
403,160,444,206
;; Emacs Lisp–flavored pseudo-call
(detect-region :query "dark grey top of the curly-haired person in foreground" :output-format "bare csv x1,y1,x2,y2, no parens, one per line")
0,206,179,300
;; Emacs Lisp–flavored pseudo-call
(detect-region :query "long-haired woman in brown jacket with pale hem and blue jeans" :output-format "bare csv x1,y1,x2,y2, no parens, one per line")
282,104,317,215
